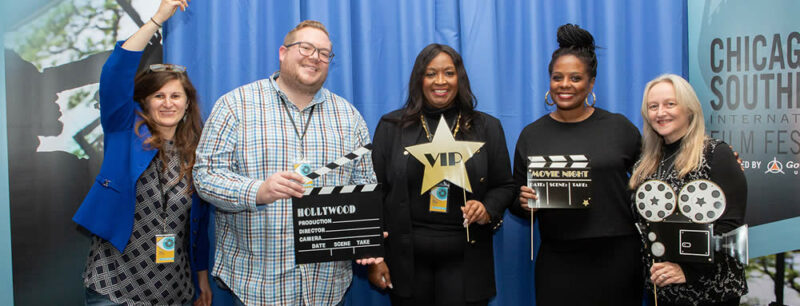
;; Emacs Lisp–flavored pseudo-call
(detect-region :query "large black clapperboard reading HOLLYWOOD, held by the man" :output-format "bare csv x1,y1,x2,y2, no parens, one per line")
292,145,384,264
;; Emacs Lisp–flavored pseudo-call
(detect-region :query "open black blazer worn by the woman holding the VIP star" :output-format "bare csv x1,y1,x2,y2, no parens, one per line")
372,110,514,301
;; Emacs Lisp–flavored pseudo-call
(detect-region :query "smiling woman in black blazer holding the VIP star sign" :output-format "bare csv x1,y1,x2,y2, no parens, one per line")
369,44,514,305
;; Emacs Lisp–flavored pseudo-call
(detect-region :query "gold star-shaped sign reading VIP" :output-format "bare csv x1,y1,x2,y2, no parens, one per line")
406,116,483,194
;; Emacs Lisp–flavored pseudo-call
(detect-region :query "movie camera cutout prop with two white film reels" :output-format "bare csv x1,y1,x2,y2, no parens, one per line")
634,179,749,265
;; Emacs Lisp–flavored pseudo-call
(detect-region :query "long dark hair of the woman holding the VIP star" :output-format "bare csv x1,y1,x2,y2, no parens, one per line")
401,43,478,132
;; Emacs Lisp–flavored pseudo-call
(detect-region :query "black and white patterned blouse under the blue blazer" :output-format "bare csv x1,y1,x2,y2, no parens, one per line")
83,142,194,305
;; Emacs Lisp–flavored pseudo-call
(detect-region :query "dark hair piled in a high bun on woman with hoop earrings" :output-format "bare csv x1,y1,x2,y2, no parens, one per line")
547,23,597,78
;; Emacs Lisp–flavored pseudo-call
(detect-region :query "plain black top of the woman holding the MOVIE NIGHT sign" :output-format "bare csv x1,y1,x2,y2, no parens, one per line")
510,107,641,242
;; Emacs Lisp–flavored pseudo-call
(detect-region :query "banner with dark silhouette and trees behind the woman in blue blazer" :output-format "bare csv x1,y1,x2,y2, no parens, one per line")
3,0,162,305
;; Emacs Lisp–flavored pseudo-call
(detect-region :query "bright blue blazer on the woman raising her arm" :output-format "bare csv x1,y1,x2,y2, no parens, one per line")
72,42,209,271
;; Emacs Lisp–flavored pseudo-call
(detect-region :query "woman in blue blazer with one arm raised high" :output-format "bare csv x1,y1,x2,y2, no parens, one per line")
73,0,211,305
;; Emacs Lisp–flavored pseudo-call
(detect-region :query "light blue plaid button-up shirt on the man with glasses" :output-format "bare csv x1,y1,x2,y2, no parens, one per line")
193,73,376,305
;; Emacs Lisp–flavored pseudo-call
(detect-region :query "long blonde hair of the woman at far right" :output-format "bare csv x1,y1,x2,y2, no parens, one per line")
629,74,706,189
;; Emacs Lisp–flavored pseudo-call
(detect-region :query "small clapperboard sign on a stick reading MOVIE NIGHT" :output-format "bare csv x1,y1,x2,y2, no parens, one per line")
528,155,592,209
